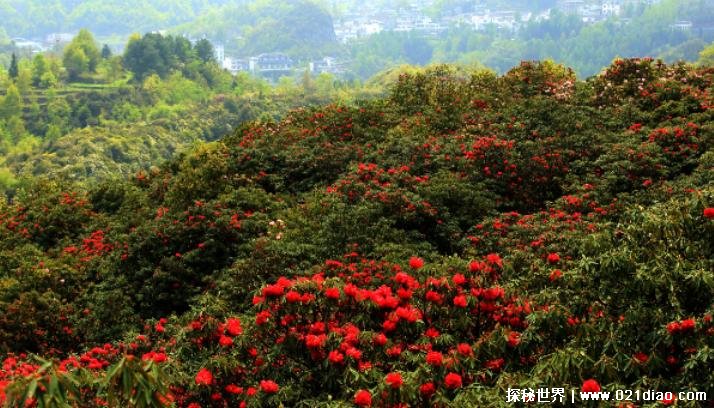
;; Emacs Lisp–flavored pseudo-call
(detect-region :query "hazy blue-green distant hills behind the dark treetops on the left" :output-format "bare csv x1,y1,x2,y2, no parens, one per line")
0,0,337,56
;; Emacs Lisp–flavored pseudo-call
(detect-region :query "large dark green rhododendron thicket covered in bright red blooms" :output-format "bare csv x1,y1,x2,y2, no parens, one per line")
0,59,714,408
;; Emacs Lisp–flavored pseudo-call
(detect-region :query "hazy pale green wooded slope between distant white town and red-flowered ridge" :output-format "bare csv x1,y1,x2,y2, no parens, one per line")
349,0,714,78
